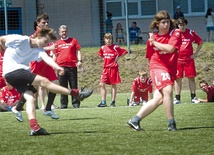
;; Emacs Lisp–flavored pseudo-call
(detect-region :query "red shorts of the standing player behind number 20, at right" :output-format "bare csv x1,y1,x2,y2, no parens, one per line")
176,60,196,78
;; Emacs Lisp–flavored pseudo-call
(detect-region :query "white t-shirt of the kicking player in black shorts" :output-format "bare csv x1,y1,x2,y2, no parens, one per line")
3,34,46,76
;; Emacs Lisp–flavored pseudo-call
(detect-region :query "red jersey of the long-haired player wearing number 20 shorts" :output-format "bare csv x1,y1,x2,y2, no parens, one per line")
146,30,182,78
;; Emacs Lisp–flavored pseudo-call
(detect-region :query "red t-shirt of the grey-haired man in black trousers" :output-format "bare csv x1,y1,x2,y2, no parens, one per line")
53,38,81,67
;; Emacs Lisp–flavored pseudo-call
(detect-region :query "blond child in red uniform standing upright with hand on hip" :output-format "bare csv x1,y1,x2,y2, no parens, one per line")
98,33,128,107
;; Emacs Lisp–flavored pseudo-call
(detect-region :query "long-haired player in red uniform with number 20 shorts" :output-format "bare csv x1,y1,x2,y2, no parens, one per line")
127,11,181,131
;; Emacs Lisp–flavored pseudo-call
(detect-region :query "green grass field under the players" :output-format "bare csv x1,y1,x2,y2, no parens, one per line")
0,91,214,155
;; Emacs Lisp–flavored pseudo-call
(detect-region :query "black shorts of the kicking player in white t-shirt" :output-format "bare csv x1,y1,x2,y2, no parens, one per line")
4,69,37,95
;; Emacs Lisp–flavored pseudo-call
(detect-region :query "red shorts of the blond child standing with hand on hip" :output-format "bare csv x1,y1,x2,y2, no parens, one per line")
100,67,121,85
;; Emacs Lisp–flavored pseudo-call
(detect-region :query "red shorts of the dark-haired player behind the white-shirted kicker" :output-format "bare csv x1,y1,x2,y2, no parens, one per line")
30,60,58,81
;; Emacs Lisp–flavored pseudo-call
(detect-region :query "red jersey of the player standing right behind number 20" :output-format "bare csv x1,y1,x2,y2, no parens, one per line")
178,29,203,62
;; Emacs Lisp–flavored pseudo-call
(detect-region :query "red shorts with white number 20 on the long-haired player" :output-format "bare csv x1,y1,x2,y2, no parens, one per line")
150,69,174,90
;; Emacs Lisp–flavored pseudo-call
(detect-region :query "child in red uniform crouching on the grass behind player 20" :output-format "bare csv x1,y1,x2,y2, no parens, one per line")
129,70,152,106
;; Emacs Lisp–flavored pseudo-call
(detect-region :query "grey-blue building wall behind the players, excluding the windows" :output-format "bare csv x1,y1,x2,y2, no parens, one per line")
5,0,206,46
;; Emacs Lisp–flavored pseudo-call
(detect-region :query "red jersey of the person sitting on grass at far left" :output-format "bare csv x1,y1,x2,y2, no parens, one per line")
0,86,21,106
